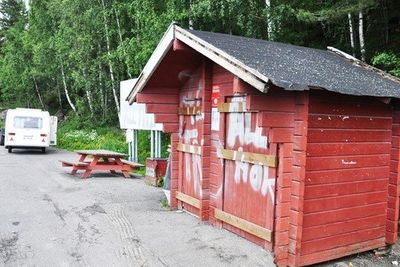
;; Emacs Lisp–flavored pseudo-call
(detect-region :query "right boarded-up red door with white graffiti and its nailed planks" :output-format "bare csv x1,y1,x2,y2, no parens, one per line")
216,97,276,245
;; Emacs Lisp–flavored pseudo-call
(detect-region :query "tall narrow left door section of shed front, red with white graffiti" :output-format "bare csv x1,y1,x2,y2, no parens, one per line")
177,59,211,220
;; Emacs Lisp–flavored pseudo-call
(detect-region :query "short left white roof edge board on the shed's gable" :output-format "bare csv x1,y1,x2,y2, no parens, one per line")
126,23,176,104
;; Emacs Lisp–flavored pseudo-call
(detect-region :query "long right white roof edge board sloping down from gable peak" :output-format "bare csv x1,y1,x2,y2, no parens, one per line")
175,26,271,93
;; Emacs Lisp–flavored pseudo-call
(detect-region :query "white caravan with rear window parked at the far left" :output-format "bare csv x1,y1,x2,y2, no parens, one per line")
4,108,57,153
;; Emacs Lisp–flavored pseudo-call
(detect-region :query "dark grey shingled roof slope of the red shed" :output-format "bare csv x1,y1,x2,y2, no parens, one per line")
188,30,400,98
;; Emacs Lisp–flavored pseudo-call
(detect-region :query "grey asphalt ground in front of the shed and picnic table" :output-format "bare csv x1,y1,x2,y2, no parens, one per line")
0,147,274,266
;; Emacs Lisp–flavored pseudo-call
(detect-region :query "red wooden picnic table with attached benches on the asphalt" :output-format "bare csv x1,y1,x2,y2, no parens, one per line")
60,149,143,178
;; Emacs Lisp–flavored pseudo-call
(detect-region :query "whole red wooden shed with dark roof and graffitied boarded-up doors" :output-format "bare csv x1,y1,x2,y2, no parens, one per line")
128,25,400,266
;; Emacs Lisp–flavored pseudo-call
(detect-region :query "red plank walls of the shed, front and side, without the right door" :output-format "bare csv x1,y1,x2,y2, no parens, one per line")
137,51,400,266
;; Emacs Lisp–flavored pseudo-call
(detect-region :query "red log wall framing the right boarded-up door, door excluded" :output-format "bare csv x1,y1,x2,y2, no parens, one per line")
210,65,302,266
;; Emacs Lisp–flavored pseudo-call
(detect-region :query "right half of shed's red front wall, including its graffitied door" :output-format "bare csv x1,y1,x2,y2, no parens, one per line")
206,65,308,266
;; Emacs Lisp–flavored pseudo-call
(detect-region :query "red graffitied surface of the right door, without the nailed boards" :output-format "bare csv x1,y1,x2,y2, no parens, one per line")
223,97,276,247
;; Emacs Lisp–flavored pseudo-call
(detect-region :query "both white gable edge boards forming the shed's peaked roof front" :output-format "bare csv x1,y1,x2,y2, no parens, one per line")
127,24,270,104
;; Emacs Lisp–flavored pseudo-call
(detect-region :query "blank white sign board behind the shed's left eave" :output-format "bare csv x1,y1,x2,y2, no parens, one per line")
119,79,163,131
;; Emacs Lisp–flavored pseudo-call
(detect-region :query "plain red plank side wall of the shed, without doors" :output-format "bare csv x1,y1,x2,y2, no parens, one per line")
300,92,392,265
